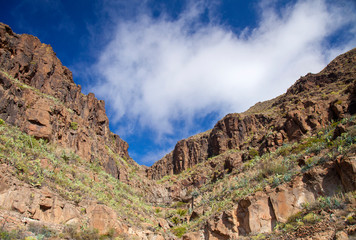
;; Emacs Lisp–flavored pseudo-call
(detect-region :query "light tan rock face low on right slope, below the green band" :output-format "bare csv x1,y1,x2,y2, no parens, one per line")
204,158,356,240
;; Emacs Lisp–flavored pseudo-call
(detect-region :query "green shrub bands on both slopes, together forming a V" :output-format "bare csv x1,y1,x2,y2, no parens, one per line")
0,111,344,239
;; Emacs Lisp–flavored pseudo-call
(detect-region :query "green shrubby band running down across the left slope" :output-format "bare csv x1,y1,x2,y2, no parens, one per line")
0,123,153,230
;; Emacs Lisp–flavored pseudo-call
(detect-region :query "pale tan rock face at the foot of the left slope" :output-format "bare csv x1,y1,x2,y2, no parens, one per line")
0,164,128,234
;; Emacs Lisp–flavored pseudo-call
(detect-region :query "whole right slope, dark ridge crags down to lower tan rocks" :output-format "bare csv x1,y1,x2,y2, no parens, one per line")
146,49,356,239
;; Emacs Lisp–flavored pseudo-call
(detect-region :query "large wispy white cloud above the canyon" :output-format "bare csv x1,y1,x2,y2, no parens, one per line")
94,0,356,141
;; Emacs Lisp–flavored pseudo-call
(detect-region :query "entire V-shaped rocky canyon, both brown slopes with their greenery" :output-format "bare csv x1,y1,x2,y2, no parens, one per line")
0,21,356,240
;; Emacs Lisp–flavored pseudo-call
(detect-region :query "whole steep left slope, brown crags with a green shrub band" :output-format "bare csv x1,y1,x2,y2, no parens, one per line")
0,23,171,238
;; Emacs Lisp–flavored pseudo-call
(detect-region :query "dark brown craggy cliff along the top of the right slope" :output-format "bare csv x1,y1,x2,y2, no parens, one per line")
147,49,356,179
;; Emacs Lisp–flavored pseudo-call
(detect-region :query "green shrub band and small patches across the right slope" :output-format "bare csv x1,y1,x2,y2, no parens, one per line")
161,117,356,231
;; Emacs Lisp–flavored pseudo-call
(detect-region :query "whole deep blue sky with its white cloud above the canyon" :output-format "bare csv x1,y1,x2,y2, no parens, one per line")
0,0,356,165
